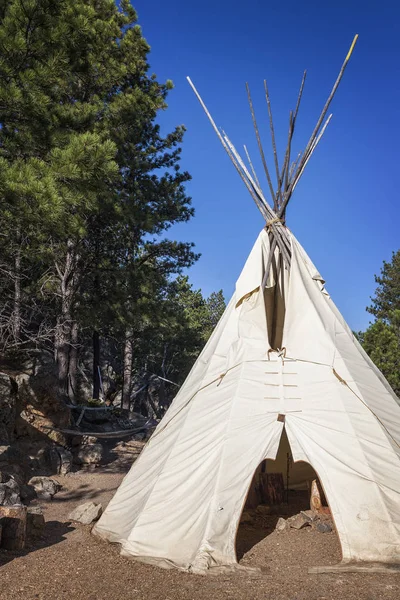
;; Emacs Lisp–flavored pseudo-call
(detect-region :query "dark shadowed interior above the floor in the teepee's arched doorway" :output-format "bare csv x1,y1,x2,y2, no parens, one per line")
236,429,329,560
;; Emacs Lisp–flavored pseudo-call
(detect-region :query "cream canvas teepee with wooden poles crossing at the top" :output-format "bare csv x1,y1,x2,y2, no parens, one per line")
93,38,400,573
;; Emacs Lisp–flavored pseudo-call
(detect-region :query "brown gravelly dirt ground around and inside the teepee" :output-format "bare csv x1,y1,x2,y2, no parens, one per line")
0,443,400,600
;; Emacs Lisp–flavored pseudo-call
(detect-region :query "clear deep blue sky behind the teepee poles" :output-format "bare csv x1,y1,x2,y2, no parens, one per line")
133,0,400,330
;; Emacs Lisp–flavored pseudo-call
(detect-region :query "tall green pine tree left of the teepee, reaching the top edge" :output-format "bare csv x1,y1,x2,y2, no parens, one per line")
0,0,196,404
